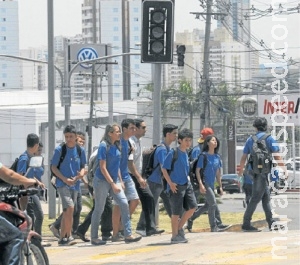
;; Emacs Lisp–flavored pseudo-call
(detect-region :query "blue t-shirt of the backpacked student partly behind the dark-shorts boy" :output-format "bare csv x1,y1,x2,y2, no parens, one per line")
148,142,170,184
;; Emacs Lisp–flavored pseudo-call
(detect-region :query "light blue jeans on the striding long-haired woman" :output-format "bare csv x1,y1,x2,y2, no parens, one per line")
91,178,132,240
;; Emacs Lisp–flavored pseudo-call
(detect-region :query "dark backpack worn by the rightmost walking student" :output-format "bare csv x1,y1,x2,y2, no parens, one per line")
246,134,272,176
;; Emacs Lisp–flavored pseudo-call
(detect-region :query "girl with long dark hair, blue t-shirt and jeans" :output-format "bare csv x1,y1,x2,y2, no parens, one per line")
196,135,225,232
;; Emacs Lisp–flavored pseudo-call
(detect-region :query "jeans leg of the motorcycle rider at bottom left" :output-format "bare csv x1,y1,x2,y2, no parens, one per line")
0,216,24,265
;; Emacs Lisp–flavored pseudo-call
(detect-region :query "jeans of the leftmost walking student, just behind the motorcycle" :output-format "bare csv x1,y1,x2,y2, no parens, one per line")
26,195,44,235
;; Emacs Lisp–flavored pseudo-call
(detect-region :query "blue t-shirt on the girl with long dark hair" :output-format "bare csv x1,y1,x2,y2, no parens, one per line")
197,152,222,189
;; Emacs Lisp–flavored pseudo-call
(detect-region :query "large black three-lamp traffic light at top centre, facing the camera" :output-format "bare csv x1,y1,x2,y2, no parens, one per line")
141,0,174,63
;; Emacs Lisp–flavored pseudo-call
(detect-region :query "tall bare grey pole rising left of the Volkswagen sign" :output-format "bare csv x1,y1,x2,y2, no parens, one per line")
47,0,56,218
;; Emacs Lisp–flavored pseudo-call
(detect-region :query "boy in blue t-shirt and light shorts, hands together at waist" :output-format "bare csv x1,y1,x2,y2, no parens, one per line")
51,125,86,246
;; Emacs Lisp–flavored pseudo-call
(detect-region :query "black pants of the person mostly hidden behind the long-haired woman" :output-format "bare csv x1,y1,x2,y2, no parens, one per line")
77,186,112,237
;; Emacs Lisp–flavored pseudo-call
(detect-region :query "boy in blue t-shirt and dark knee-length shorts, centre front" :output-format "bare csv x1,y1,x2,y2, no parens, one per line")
162,129,197,244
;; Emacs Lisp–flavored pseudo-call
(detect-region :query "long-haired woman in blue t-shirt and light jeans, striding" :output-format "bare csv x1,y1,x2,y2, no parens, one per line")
91,124,141,245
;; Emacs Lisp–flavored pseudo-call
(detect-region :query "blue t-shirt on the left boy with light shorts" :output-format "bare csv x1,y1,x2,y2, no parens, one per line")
51,145,86,190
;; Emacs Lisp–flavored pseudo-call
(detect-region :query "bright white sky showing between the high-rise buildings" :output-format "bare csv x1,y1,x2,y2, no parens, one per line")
18,0,300,62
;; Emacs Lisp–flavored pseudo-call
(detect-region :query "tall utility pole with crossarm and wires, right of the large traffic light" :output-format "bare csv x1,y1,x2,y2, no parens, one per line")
200,0,212,130
